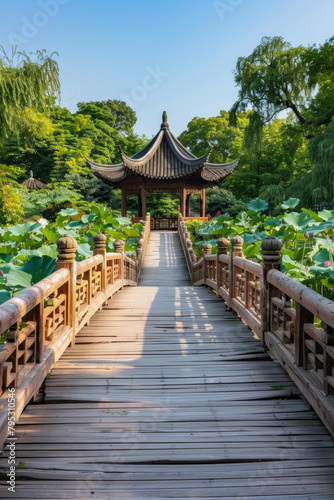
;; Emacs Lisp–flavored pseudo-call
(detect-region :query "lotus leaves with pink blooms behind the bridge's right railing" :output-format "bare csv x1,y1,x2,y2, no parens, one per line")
186,198,334,299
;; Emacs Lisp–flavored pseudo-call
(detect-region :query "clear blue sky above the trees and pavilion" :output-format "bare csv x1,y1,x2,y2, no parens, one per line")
0,0,334,137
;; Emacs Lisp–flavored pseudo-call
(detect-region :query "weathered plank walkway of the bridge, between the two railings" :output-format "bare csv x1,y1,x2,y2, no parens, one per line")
0,232,334,500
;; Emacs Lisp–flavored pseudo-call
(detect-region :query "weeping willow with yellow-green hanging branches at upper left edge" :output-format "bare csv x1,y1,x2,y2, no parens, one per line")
0,47,60,144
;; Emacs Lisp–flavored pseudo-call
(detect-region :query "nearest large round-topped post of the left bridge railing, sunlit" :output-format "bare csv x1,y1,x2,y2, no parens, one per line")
56,234,77,346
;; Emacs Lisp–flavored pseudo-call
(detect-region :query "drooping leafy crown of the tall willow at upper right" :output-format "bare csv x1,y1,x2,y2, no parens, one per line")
230,37,334,138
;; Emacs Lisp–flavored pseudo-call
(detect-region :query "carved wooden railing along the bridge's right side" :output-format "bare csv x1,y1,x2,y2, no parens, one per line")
179,216,334,435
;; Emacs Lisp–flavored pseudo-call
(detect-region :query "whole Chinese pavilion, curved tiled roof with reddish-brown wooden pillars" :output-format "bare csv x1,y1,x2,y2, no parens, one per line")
87,111,239,217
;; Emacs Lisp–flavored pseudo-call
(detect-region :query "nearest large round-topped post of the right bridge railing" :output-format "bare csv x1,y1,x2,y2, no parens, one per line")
261,236,283,345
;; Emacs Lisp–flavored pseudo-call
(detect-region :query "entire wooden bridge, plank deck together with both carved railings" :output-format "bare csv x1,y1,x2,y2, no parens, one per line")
0,218,334,500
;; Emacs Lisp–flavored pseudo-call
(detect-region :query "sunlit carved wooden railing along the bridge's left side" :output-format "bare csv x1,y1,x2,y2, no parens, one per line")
0,216,150,443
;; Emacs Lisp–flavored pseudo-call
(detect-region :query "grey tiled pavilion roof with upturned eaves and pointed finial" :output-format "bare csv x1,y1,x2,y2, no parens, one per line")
86,112,239,185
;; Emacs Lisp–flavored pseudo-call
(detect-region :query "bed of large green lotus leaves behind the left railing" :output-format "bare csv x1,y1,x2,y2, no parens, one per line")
0,204,143,304
